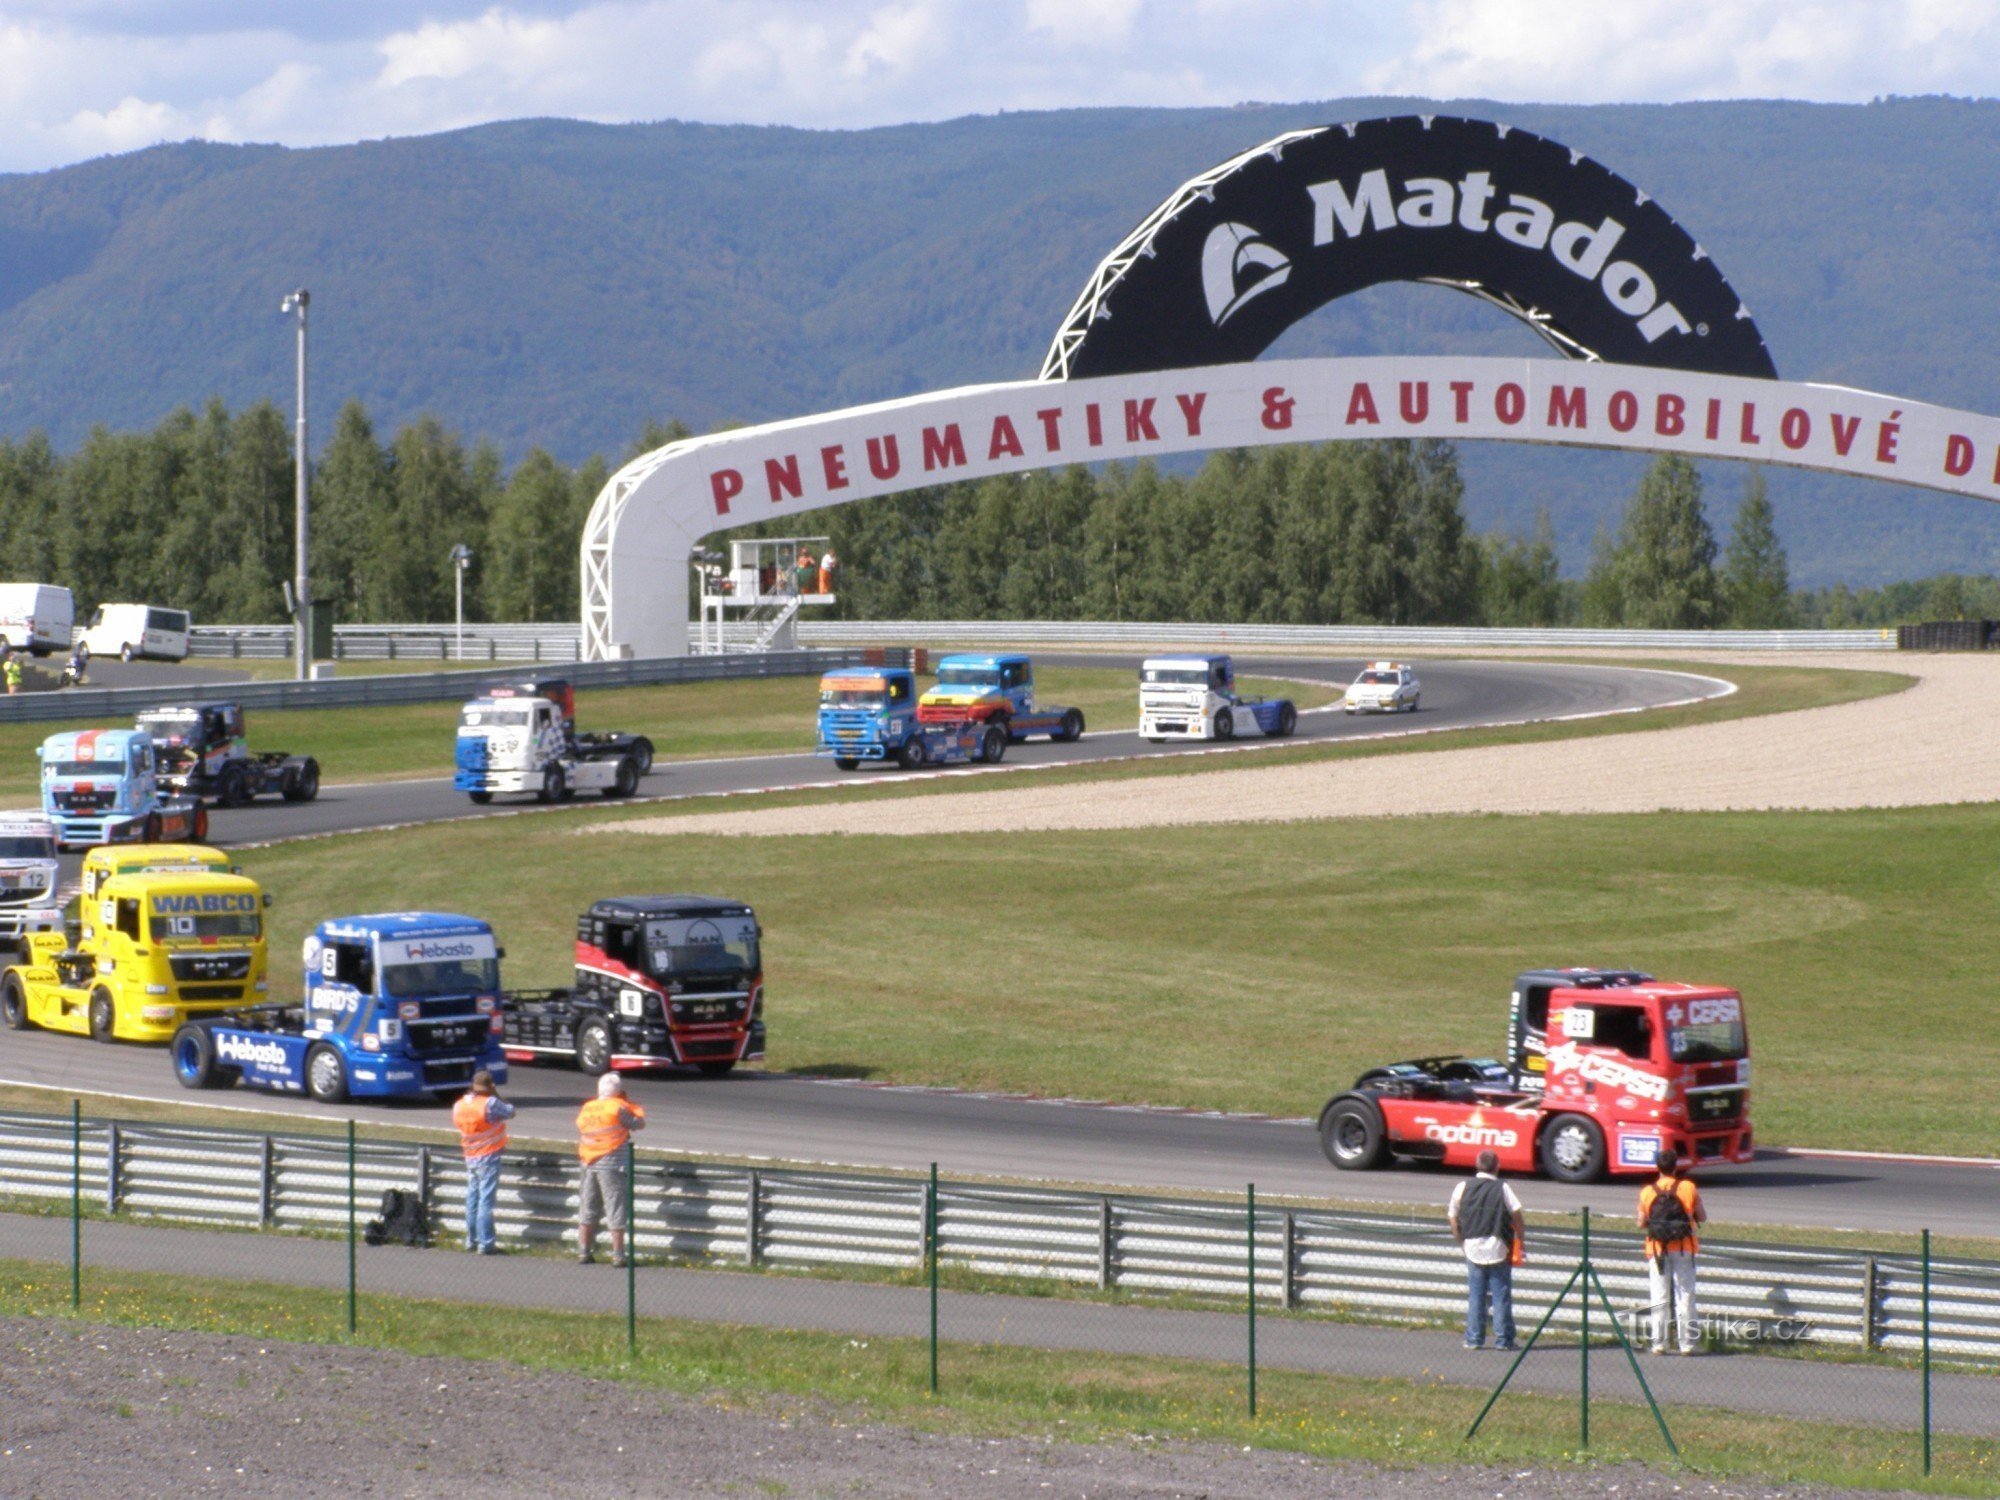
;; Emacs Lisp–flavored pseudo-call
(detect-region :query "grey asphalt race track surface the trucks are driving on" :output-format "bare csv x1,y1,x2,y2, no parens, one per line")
15,654,1996,1234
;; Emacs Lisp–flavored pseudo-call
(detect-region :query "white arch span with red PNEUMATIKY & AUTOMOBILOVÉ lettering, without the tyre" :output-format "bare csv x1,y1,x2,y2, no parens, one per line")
582,356,2000,660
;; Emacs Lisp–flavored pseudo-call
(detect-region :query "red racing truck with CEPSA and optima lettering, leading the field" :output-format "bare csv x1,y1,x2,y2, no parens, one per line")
1320,968,1752,1182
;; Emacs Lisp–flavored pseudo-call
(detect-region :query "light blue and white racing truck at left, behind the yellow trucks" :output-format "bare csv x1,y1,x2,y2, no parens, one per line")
40,730,208,848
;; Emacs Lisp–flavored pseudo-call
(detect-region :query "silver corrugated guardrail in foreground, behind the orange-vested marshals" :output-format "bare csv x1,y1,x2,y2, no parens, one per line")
0,1112,2000,1364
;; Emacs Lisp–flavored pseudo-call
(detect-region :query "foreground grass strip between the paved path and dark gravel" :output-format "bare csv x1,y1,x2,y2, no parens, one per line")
0,1262,2000,1494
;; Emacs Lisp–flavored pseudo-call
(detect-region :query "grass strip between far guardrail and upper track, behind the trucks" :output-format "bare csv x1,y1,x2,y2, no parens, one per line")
0,664,1338,812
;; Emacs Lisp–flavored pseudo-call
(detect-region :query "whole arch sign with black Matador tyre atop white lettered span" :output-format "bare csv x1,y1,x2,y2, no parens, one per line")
582,116,2000,660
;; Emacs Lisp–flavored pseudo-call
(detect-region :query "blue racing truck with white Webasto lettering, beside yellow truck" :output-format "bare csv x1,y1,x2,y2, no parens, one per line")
168,912,506,1104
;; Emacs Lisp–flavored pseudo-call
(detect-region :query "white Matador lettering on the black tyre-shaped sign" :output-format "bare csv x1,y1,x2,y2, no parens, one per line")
1306,168,1694,344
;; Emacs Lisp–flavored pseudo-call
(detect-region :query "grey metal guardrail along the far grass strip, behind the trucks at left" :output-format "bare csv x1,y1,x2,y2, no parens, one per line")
0,650,860,724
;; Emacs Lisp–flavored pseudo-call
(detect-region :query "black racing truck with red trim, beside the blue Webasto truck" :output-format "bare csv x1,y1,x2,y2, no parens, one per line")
500,896,764,1076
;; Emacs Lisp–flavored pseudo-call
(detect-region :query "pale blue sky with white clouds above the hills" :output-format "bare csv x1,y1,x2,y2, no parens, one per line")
0,0,2000,172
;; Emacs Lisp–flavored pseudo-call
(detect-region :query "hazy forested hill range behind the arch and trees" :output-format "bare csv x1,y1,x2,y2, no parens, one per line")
0,98,2000,584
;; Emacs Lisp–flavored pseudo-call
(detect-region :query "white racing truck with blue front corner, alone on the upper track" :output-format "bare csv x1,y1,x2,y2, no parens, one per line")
452,680,652,804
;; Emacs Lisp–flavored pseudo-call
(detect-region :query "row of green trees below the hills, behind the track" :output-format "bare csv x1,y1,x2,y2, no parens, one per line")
0,402,2000,628
